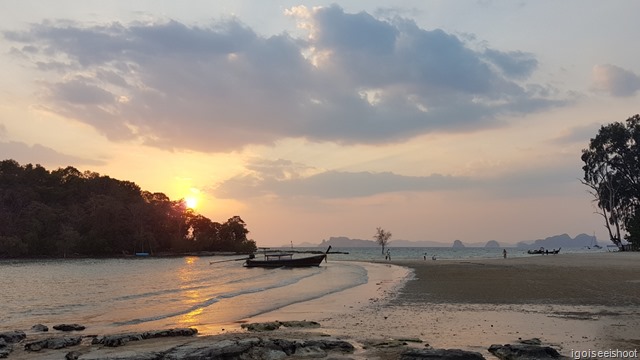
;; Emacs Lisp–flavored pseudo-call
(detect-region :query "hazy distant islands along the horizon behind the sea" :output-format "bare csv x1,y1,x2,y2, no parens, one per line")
310,234,599,249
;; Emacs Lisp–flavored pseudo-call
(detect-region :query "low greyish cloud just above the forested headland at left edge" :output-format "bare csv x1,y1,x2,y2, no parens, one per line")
0,141,105,167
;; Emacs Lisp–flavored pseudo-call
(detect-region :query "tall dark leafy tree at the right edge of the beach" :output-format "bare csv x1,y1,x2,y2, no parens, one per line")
581,115,640,247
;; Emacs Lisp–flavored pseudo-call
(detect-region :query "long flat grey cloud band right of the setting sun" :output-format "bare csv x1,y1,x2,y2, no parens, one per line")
214,154,582,201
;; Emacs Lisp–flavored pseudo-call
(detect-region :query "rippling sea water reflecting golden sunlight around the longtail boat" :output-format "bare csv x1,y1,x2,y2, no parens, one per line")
0,247,606,334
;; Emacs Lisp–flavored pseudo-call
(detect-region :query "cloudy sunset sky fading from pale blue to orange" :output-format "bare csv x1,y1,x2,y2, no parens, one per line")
0,0,640,246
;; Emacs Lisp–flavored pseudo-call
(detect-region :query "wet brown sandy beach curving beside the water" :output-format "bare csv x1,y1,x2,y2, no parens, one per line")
9,253,640,359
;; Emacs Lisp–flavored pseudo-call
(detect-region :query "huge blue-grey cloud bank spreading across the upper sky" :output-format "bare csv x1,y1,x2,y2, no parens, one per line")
3,5,566,152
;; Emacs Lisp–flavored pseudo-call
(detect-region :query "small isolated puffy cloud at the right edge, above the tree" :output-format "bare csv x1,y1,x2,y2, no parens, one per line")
592,65,640,97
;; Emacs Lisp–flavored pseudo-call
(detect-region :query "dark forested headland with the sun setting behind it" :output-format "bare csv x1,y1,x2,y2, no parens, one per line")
0,160,256,258
